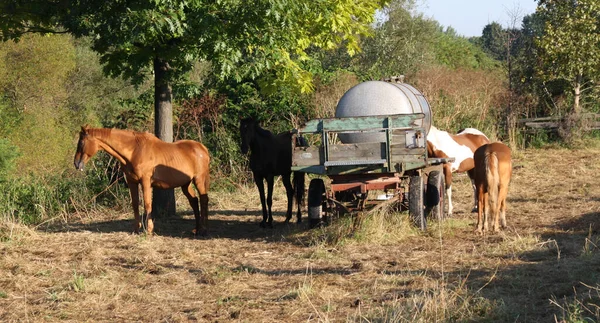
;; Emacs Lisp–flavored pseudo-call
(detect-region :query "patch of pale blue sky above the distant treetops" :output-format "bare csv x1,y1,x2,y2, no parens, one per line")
417,0,537,37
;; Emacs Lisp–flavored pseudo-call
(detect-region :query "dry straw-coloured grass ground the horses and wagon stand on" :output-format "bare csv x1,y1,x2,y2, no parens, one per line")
0,148,600,322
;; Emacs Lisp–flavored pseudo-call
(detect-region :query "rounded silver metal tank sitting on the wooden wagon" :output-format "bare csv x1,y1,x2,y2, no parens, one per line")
335,81,431,143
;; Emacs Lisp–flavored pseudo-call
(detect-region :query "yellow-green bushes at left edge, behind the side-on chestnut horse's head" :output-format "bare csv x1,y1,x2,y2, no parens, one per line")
0,31,143,224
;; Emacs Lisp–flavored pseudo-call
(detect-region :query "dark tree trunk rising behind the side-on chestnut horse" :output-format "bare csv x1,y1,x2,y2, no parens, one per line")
152,57,175,217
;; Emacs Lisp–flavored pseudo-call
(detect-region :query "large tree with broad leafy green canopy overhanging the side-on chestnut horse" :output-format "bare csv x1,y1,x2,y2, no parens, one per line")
0,0,388,218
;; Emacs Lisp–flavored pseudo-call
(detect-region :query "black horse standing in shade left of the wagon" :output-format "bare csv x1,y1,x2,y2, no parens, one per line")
240,118,305,228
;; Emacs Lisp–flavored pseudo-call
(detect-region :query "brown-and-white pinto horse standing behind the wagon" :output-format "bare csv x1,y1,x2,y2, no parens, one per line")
427,126,490,216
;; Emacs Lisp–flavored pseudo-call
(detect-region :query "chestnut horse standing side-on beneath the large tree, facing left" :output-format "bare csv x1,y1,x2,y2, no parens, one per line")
74,126,210,234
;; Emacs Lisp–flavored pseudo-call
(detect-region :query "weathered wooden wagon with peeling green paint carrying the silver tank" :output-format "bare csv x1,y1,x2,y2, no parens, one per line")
292,113,453,230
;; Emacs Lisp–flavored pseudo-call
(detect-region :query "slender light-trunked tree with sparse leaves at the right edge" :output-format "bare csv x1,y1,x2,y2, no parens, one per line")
536,0,600,118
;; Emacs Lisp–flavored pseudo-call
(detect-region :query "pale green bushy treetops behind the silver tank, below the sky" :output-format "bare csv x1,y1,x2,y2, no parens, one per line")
357,0,497,79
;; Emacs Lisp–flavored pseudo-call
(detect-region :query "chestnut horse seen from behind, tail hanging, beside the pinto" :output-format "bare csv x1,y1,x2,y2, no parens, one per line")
473,142,512,234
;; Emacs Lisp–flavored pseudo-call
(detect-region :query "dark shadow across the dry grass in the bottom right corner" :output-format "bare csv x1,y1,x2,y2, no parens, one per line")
422,212,600,322
